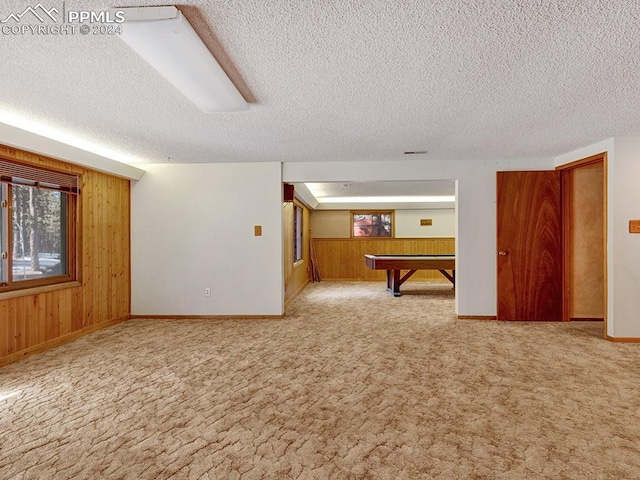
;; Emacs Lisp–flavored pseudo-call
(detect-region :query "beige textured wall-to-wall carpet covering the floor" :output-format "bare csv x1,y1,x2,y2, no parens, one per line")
0,282,640,479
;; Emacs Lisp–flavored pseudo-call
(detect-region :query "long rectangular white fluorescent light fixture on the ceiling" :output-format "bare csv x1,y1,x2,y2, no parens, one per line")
119,6,249,113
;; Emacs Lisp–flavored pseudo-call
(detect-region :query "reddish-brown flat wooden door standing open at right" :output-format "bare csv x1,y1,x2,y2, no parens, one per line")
497,171,563,321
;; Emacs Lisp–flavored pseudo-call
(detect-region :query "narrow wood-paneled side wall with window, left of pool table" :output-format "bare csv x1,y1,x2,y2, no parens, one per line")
282,202,310,304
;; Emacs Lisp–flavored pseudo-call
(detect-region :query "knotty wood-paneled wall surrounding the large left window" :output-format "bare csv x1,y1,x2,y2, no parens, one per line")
0,146,131,365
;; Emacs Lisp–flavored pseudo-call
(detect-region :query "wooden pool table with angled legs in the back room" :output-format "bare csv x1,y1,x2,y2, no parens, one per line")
364,255,456,297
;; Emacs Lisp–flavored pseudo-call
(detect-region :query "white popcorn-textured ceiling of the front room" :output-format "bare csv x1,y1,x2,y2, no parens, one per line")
0,0,640,166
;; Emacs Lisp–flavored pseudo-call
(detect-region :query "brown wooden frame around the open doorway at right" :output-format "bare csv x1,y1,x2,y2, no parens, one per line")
556,152,609,338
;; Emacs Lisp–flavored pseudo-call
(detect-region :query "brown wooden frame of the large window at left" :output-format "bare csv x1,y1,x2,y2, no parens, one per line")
0,157,81,297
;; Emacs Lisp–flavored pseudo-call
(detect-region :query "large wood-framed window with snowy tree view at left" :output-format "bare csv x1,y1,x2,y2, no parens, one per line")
0,159,80,292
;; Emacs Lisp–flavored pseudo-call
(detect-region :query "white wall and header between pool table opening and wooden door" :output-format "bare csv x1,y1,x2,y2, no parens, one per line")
283,158,554,315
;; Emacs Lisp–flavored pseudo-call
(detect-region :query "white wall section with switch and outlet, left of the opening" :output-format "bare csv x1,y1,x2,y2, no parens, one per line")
131,163,284,315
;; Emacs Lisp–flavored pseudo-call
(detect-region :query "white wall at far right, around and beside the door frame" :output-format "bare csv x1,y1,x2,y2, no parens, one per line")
556,137,640,338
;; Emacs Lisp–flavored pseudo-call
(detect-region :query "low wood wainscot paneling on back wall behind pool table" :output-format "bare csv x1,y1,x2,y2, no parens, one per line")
313,238,455,281
